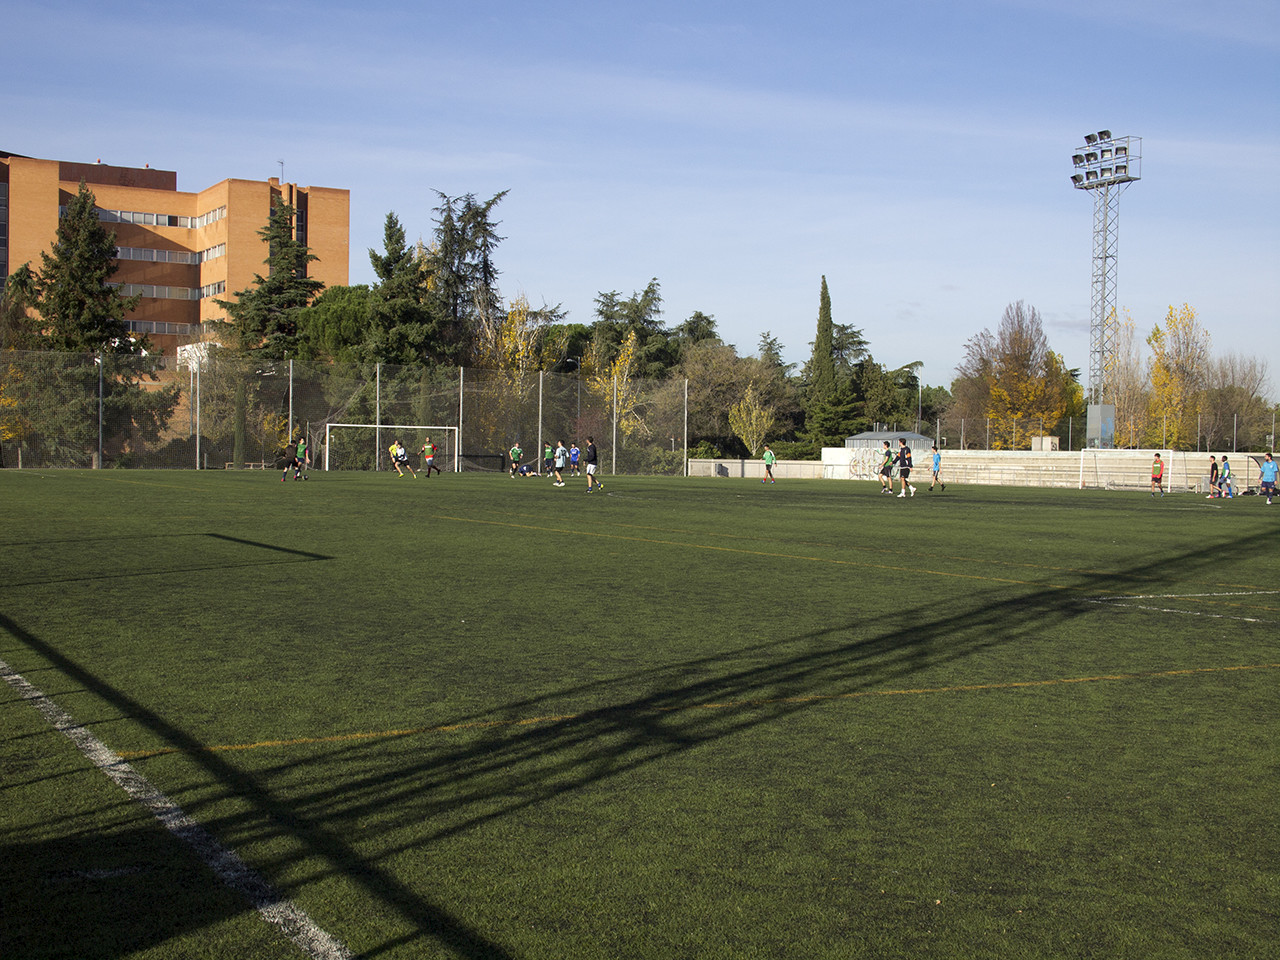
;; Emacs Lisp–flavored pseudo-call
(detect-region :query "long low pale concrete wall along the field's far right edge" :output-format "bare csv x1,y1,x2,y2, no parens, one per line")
689,447,1258,493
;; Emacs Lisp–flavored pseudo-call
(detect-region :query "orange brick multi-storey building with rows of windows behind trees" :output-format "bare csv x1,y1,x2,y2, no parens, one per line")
0,151,351,353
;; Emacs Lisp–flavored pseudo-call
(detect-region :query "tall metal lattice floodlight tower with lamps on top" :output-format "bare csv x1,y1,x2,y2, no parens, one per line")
1071,131,1142,447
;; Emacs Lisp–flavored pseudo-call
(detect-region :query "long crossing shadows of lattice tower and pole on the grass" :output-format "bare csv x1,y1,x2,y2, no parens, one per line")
0,535,1270,959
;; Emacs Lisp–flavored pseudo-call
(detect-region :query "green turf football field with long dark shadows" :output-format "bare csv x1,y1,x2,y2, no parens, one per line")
0,470,1280,960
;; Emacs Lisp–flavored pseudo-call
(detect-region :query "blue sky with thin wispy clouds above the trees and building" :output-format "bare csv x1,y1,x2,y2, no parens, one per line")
0,0,1280,384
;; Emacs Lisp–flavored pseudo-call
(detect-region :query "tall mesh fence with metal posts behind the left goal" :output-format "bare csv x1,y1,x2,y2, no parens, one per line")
0,344,696,475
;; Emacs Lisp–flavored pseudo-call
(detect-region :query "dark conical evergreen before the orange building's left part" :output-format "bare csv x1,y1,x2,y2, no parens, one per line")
36,182,150,353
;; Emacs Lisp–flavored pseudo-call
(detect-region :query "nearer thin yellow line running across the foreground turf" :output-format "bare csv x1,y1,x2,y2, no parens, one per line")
116,663,1280,760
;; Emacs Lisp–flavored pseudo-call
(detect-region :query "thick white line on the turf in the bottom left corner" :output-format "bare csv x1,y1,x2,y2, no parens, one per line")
0,660,353,960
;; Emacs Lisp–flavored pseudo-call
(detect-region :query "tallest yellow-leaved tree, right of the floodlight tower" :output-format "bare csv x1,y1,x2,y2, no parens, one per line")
1146,303,1210,448
